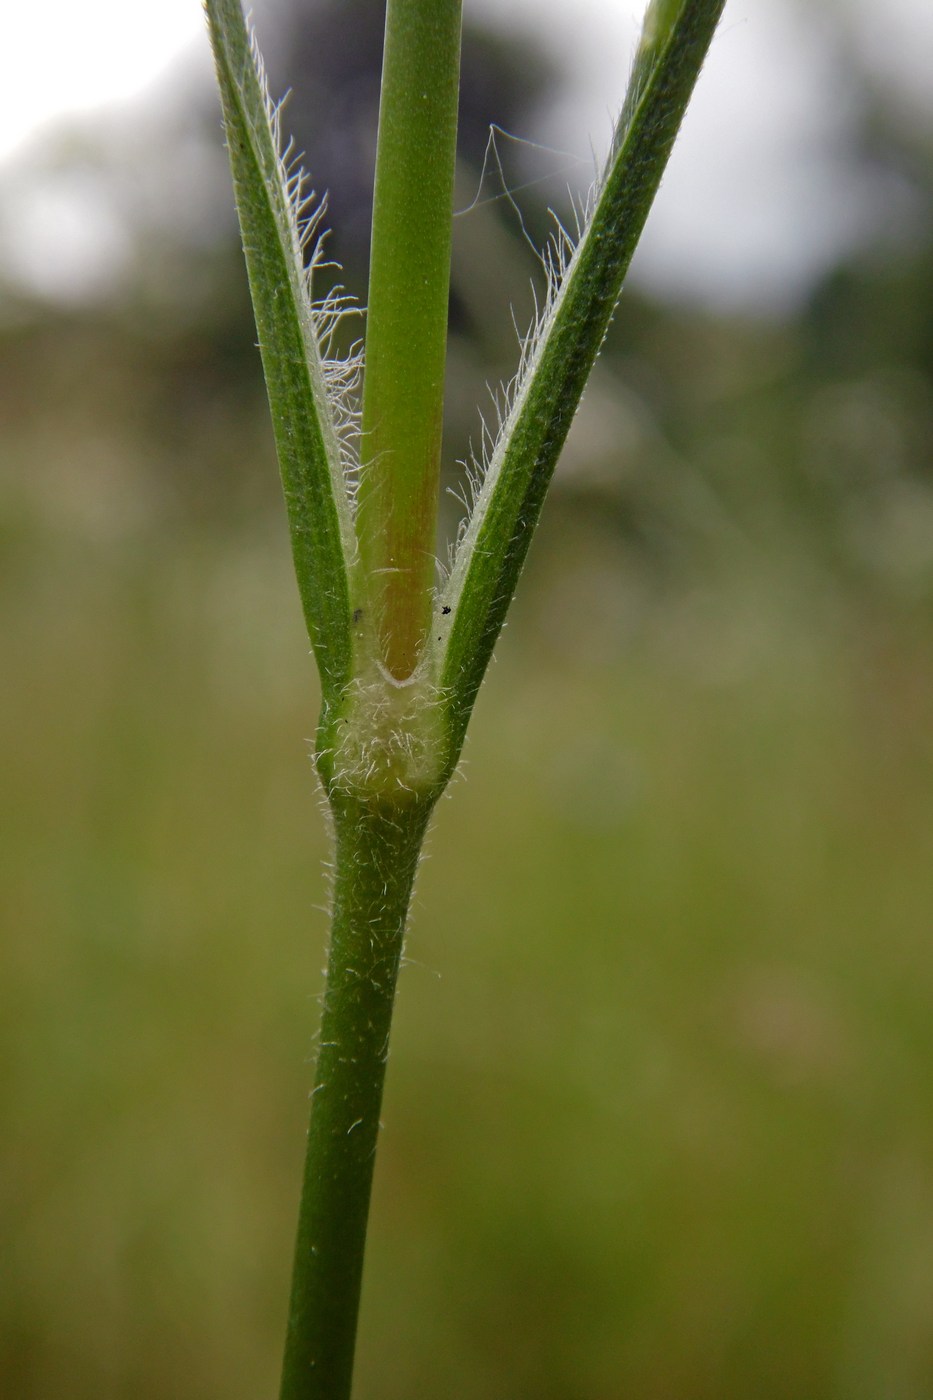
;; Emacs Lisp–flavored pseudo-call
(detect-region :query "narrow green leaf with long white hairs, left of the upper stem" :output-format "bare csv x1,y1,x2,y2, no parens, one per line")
206,0,354,706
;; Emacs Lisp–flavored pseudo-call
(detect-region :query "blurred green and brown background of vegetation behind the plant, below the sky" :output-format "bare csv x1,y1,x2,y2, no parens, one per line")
0,0,933,1400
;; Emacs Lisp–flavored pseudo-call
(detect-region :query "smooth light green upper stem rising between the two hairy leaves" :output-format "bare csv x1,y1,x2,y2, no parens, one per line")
357,0,461,679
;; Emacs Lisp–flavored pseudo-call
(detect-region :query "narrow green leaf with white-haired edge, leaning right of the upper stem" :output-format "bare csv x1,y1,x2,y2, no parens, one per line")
436,0,724,760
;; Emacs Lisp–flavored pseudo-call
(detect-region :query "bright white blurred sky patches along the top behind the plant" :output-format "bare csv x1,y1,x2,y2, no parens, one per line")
0,0,933,307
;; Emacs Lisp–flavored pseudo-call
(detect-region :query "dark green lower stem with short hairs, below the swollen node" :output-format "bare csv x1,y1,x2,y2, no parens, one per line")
282,795,433,1400
